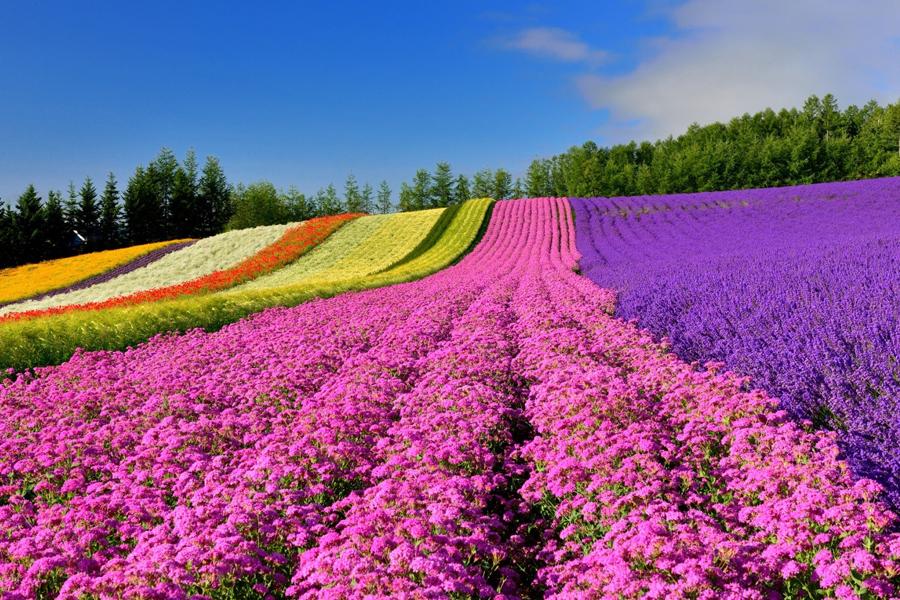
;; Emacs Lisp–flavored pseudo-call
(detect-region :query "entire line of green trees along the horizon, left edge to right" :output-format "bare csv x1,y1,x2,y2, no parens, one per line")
0,94,900,267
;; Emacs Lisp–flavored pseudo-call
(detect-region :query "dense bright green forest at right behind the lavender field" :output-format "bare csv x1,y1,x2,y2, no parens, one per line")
525,94,900,197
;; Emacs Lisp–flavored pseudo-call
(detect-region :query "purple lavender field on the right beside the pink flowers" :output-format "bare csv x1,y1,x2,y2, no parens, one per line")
571,178,900,508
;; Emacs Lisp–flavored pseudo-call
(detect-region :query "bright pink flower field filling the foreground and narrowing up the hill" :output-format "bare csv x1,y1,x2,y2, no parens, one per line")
0,199,900,599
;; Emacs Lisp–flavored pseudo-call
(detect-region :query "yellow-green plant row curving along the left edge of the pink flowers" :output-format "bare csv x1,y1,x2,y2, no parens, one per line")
0,199,493,370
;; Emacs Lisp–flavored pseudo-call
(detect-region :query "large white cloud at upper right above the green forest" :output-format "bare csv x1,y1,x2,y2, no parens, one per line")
576,0,900,141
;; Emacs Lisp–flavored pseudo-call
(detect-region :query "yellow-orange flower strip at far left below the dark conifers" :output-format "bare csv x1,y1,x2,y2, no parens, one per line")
0,240,193,307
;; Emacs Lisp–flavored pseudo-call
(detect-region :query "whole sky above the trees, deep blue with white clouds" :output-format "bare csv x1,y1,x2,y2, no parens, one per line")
0,0,900,201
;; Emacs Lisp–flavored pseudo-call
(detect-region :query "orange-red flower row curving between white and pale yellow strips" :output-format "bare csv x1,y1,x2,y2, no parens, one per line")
0,213,361,322
